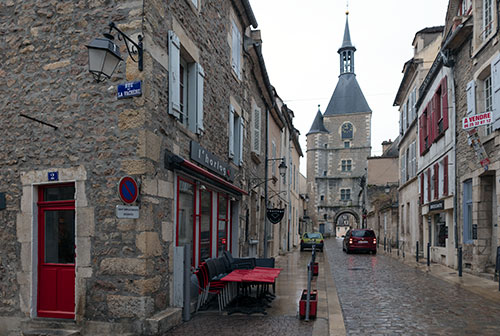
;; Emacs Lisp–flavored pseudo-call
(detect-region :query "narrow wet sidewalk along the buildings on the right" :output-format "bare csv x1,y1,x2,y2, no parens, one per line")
377,246,500,303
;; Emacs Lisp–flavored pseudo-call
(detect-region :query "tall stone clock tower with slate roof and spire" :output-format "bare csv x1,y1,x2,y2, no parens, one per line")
306,12,372,235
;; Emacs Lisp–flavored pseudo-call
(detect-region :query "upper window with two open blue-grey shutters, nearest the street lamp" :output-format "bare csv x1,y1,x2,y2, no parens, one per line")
168,31,205,133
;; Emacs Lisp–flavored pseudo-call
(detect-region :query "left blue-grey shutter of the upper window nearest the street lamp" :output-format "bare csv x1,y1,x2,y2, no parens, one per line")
168,30,181,118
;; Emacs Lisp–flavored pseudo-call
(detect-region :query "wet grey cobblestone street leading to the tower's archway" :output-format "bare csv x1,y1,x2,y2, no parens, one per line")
326,239,500,335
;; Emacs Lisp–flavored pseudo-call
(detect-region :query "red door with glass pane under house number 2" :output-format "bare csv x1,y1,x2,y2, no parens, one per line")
37,184,75,319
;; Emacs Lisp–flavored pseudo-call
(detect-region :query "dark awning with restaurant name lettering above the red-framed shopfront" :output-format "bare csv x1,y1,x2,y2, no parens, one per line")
165,151,248,196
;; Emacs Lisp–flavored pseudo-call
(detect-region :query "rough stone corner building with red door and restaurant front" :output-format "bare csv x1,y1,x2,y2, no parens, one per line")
0,0,298,335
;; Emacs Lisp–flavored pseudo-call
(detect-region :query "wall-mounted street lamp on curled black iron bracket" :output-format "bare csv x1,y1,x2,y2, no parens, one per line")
87,22,144,82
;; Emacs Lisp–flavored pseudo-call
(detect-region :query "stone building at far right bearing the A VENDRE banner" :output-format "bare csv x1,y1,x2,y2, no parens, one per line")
442,0,500,273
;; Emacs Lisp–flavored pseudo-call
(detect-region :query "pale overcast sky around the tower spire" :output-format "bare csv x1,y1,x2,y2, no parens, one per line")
250,0,448,175
